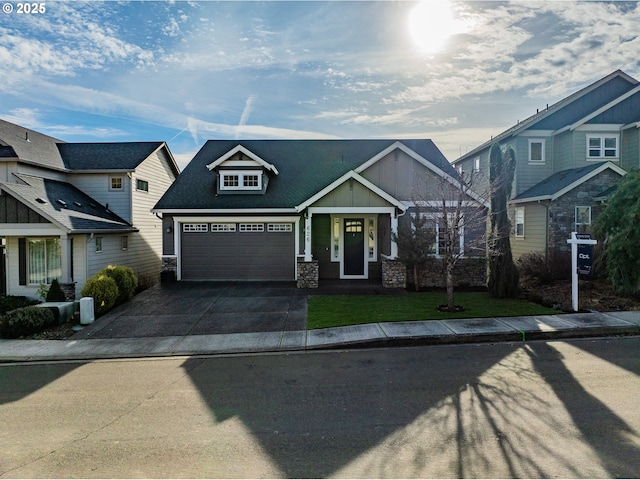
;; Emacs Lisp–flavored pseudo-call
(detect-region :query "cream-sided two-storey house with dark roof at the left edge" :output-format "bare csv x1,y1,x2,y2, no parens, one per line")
0,120,179,297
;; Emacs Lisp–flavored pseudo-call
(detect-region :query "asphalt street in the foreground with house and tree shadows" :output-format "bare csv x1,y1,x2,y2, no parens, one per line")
0,337,640,478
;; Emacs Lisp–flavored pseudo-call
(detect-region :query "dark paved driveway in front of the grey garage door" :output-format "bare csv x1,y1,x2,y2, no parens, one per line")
72,282,307,339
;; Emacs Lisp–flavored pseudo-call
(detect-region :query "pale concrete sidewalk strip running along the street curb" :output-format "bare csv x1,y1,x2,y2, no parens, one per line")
0,311,640,362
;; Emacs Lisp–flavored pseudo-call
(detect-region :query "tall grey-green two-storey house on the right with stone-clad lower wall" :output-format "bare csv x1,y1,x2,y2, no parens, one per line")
453,70,640,258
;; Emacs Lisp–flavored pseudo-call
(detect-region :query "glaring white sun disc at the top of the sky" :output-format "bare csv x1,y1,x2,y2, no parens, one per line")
409,0,459,53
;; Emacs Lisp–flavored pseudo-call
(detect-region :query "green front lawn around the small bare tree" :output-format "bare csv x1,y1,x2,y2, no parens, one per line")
307,292,558,329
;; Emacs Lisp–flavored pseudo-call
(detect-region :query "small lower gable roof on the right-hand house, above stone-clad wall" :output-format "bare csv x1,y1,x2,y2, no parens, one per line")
511,162,626,203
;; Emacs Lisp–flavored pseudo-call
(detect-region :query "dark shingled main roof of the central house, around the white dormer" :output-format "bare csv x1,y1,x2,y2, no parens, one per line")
154,140,457,210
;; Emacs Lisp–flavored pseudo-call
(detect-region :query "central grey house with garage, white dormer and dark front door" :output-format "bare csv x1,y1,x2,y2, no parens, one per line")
154,140,485,287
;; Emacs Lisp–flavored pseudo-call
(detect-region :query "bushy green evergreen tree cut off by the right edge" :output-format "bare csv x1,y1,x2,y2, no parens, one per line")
595,170,640,295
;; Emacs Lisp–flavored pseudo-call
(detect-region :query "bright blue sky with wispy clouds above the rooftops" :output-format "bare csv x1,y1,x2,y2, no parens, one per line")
0,0,640,167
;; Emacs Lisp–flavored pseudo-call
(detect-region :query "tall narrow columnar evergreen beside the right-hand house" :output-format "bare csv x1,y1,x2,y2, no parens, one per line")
487,143,520,298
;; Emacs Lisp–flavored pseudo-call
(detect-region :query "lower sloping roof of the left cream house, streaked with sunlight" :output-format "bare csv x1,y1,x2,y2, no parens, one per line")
0,174,137,233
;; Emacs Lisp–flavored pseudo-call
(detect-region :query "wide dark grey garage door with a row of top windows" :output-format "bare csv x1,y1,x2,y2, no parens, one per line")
181,223,295,280
